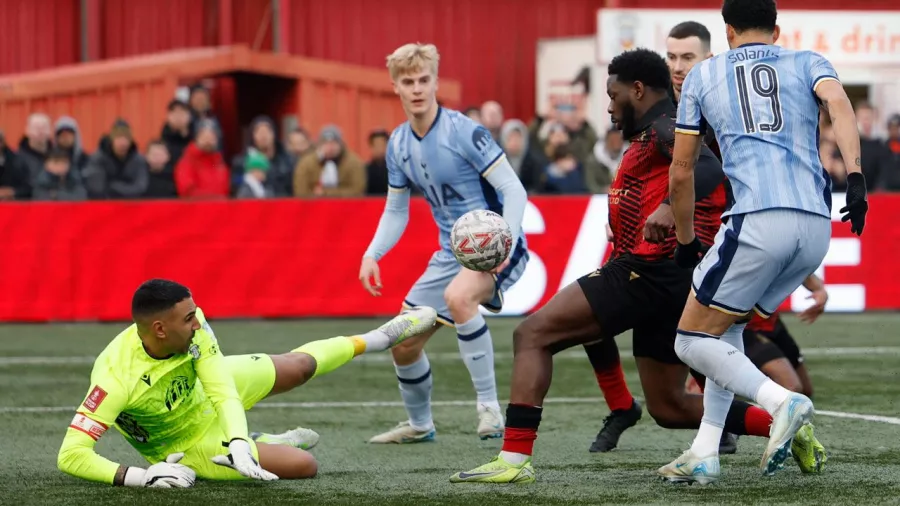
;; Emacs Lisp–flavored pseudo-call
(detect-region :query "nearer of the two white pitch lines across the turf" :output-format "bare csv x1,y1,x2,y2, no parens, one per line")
0,397,900,425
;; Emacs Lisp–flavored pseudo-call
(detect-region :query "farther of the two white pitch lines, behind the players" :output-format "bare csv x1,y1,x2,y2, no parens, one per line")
0,346,900,367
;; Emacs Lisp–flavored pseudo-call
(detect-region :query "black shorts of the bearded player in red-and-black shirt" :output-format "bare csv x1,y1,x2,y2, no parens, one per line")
578,255,691,364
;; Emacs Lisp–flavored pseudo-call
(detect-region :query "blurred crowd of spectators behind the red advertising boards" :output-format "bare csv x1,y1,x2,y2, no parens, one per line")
0,86,900,200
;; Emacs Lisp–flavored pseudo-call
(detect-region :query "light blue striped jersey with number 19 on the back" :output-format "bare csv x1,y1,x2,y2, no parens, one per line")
676,44,838,217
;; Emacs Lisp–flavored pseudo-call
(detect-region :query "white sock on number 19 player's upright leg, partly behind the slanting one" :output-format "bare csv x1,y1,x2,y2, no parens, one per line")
691,323,747,457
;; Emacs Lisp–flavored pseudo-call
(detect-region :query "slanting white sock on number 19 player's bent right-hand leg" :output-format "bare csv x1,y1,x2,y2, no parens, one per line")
675,331,770,404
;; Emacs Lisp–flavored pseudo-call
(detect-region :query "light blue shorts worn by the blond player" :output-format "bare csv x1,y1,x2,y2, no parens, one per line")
403,239,528,327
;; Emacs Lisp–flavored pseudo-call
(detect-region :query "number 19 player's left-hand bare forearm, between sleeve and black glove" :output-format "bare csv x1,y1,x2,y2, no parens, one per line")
669,133,702,245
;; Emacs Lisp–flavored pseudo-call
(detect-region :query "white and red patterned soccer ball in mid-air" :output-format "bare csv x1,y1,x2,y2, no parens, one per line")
450,209,512,272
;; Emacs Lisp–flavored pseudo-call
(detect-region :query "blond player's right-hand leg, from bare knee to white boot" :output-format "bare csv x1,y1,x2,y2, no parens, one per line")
444,269,503,440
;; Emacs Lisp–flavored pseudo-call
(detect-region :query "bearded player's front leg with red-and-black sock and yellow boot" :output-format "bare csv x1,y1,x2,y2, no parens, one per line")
450,283,601,483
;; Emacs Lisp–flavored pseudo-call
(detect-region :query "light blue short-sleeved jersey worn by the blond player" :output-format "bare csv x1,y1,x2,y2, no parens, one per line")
387,107,526,255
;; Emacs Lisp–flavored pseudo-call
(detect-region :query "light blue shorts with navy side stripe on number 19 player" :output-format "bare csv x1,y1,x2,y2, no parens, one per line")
693,209,831,317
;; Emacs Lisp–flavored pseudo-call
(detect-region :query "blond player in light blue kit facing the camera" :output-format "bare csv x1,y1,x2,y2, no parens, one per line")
359,44,528,443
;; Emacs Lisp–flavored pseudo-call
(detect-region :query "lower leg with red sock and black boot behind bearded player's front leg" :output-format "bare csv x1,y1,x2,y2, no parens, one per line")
584,339,643,453
